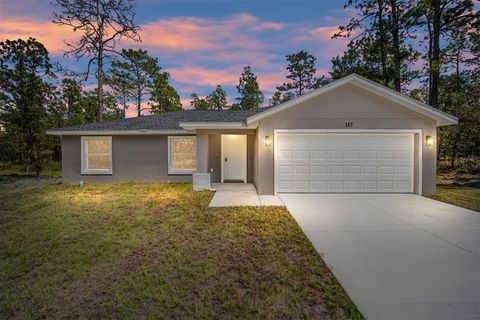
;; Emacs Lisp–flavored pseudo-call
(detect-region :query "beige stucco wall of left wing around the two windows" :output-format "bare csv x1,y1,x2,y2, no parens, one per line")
62,135,192,183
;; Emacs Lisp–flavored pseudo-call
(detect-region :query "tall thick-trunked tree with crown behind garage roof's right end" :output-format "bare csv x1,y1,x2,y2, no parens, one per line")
414,0,476,107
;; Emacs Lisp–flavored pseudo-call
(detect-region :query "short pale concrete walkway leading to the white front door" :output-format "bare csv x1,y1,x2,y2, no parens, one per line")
209,183,285,207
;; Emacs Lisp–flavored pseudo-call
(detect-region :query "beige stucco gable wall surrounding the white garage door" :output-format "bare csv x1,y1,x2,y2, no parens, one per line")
254,85,436,195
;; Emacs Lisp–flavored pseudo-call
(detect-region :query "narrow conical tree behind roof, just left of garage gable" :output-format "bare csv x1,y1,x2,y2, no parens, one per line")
237,66,263,110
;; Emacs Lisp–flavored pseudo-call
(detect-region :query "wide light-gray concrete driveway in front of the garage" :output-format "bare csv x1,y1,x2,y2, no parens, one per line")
280,194,480,319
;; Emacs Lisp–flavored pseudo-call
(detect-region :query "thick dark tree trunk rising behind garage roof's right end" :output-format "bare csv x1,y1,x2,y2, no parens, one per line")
428,0,442,107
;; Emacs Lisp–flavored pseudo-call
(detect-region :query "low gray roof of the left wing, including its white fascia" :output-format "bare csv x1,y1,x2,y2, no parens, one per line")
47,107,270,135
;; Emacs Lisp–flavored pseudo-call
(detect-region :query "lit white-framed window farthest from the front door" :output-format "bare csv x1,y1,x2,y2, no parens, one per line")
82,137,112,174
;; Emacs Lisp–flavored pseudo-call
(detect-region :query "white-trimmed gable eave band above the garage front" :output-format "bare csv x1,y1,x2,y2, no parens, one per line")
247,74,458,126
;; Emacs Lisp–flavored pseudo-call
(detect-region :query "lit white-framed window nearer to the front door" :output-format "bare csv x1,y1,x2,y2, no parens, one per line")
168,136,197,174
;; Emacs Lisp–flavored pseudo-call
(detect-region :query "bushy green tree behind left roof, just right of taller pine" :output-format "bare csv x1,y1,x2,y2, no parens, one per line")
150,72,182,113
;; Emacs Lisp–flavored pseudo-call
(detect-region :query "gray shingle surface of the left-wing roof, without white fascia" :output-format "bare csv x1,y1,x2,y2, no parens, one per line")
51,107,270,131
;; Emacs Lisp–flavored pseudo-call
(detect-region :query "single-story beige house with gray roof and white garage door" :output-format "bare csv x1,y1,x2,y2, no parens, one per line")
48,75,457,195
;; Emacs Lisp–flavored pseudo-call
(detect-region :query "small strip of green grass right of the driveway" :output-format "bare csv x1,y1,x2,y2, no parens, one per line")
430,185,480,211
